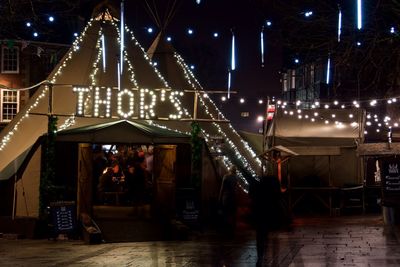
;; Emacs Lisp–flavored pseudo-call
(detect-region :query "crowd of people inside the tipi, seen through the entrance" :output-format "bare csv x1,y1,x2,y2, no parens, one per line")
93,145,153,205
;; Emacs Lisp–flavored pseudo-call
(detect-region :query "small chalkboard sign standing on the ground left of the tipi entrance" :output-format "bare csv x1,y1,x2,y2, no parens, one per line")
50,201,76,233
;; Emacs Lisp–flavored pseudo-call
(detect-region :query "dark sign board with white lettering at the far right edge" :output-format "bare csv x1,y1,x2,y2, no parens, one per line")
382,157,400,206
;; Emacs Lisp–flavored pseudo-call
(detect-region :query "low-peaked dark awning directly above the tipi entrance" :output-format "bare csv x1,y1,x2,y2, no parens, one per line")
56,120,190,144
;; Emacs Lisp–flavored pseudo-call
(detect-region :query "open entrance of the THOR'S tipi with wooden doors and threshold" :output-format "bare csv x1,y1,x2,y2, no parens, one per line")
78,144,177,242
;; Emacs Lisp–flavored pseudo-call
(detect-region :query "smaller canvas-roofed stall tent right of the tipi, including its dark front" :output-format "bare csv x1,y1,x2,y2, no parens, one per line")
266,108,365,187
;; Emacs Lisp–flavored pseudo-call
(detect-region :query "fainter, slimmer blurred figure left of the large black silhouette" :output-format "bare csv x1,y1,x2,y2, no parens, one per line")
219,166,238,238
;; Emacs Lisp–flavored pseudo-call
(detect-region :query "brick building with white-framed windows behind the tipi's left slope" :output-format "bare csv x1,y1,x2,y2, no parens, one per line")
0,40,70,129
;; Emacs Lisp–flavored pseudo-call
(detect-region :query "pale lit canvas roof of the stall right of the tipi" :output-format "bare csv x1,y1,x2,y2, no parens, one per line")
268,108,365,148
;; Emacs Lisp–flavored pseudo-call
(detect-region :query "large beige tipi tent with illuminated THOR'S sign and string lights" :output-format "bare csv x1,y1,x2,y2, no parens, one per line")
0,5,260,230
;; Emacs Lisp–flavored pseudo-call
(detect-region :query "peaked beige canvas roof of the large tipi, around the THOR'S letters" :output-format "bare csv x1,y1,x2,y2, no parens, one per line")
0,7,260,182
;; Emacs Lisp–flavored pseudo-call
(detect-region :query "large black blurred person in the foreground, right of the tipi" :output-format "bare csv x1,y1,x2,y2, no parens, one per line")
250,175,283,266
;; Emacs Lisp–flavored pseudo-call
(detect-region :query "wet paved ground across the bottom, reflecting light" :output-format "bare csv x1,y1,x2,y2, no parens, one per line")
0,215,400,267
